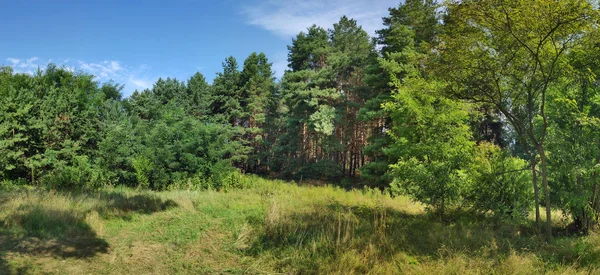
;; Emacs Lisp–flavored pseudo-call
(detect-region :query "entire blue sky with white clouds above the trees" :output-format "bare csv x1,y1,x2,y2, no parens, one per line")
0,0,400,96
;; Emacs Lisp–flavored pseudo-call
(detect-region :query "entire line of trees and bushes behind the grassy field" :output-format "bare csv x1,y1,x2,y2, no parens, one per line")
0,0,600,240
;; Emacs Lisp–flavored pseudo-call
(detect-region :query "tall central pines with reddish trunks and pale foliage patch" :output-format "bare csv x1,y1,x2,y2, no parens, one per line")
269,16,376,178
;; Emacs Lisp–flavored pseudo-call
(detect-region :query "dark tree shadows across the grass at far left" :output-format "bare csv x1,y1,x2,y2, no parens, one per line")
0,192,177,274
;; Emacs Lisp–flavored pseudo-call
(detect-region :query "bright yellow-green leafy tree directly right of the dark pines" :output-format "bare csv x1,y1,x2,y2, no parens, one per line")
383,48,474,215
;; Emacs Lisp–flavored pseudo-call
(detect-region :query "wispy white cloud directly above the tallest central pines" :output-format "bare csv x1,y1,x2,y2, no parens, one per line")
242,0,400,38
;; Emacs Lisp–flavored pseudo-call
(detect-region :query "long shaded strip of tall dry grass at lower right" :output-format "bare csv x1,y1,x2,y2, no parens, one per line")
248,203,600,270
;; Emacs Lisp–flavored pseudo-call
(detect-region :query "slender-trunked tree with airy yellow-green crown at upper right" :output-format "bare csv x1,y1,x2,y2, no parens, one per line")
438,0,593,241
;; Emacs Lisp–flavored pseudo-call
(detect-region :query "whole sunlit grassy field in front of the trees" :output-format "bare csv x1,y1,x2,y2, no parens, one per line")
0,177,600,274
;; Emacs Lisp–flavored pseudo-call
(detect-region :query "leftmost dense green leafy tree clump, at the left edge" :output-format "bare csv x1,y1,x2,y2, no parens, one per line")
0,64,104,186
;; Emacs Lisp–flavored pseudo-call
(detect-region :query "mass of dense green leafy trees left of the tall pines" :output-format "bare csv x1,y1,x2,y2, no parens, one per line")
0,65,248,192
